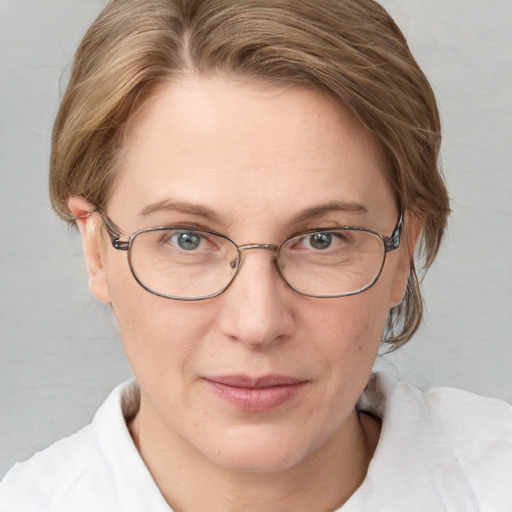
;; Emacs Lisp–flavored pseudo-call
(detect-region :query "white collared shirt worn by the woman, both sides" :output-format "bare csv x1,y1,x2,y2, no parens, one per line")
0,374,512,512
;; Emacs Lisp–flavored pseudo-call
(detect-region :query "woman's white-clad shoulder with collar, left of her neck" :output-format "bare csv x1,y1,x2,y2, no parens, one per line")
0,382,166,512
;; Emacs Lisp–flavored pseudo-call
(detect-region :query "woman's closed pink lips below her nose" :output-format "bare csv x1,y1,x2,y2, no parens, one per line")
205,375,307,412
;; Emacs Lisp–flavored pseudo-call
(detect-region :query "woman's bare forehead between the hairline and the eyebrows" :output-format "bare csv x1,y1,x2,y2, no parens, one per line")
111,73,394,228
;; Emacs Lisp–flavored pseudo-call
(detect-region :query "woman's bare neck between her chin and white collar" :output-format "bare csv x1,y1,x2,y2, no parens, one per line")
130,402,380,512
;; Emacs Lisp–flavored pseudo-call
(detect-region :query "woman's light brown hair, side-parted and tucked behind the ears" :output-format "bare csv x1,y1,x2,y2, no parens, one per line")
50,0,449,348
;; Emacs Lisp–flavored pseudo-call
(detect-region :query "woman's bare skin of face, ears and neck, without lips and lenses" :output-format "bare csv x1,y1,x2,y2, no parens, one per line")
69,76,419,512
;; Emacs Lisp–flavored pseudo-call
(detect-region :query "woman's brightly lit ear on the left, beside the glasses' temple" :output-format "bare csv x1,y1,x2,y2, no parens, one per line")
68,196,110,303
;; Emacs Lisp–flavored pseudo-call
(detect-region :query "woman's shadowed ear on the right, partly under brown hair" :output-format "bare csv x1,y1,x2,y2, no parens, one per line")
390,210,423,308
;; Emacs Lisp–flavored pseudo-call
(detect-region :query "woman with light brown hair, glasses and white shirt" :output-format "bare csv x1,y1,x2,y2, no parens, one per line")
0,0,512,512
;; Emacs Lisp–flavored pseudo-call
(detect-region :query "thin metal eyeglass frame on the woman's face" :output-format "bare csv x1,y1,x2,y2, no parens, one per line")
91,208,404,301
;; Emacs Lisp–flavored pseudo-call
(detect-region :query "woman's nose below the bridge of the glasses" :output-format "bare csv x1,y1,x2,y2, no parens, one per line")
219,245,298,348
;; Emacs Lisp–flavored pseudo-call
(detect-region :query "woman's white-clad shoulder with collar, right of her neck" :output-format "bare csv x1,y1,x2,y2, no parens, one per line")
352,374,512,512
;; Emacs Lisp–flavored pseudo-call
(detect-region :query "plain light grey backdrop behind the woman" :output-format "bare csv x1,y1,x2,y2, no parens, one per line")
0,0,512,475
